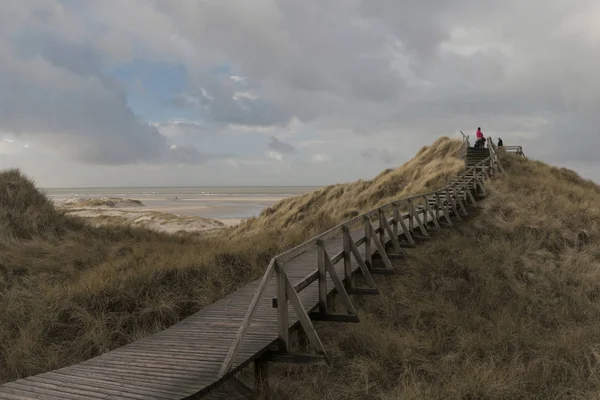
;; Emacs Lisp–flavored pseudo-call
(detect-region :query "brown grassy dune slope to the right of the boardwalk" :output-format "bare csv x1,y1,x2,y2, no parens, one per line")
272,152,600,400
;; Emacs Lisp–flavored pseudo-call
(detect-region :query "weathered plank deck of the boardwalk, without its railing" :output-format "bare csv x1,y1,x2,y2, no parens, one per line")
0,219,432,400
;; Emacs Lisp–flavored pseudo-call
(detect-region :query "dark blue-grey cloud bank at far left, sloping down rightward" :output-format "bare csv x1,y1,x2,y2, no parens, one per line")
0,21,202,165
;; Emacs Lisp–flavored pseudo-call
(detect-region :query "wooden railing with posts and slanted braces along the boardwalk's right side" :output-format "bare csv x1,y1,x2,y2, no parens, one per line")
219,149,499,378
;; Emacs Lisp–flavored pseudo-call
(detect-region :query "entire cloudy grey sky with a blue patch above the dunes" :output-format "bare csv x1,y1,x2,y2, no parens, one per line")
0,0,600,187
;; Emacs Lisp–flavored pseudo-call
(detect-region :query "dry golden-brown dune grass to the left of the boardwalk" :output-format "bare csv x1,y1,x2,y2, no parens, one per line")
0,138,464,382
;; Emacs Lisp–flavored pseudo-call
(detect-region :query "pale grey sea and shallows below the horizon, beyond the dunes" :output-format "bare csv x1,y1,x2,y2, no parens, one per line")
43,186,319,219
